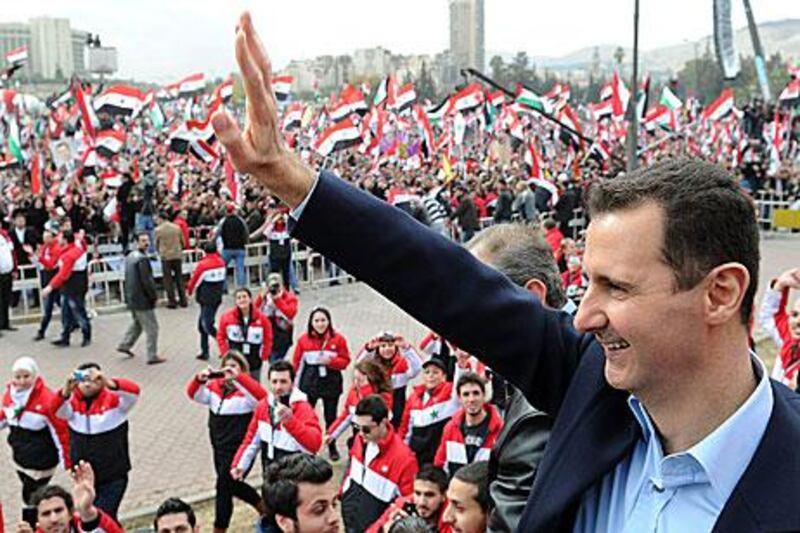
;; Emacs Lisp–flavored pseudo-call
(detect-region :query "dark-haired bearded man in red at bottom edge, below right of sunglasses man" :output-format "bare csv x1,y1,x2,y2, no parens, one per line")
366,465,452,533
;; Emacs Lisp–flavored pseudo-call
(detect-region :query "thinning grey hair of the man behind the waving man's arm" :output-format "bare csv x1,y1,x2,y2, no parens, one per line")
467,223,567,309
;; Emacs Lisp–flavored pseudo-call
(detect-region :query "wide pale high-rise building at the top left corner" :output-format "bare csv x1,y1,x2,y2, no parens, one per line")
0,17,87,80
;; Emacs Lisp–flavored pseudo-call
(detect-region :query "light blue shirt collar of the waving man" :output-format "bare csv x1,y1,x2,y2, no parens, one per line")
628,353,775,503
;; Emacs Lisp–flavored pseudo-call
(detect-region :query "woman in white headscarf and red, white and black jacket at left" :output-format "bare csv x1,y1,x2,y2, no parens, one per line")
0,357,71,505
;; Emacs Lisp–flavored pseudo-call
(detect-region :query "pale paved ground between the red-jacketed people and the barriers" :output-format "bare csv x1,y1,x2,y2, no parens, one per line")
0,237,800,522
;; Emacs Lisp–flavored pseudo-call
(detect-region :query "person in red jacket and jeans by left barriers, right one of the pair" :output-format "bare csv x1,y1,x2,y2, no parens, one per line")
42,229,92,346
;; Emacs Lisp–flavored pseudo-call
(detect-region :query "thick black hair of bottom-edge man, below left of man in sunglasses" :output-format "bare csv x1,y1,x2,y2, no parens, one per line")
263,453,333,528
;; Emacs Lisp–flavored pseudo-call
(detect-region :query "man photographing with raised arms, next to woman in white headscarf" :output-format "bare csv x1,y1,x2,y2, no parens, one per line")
53,363,139,520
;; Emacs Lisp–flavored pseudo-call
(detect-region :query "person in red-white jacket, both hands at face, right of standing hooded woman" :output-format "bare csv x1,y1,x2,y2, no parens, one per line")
356,331,422,429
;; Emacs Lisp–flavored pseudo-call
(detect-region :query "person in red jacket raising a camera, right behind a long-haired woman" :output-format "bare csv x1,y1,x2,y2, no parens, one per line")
253,273,299,363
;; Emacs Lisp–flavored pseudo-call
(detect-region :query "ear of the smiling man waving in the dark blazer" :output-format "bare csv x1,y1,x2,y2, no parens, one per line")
705,263,751,325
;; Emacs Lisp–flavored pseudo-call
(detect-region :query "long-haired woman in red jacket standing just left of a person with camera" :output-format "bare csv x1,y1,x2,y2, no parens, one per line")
217,287,272,381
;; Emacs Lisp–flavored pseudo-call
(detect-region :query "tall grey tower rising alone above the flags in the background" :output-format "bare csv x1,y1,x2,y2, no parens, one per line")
450,0,485,78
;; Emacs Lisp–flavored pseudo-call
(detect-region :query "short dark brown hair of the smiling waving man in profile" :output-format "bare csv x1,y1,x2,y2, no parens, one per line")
589,157,760,324
